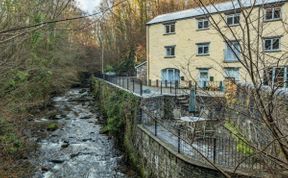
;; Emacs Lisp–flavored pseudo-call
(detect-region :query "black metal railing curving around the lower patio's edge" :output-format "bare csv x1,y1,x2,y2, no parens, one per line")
139,108,275,173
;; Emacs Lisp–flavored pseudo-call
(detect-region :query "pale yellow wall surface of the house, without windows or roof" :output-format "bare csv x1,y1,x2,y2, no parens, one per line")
147,3,288,82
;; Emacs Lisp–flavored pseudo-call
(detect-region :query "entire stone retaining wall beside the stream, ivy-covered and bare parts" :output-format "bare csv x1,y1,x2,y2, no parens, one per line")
92,79,252,178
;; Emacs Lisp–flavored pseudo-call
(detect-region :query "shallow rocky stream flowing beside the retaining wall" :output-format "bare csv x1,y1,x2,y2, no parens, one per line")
33,89,129,178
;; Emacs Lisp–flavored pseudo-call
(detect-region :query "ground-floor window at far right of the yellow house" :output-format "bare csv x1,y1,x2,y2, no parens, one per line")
264,66,288,88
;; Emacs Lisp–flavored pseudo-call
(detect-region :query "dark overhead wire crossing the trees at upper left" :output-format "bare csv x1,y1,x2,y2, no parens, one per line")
0,0,127,34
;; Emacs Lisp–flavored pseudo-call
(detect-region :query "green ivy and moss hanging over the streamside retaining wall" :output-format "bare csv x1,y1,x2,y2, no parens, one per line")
92,78,147,177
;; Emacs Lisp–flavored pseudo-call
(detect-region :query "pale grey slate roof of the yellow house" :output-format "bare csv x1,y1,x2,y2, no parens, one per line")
147,0,287,25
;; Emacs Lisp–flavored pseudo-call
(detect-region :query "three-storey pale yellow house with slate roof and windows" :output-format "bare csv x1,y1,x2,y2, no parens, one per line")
146,0,288,87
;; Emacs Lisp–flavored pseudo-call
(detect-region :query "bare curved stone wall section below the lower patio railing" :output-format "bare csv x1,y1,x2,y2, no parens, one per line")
135,126,224,178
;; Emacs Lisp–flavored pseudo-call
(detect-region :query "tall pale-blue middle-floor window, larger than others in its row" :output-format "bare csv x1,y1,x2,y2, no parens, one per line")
224,41,241,62
